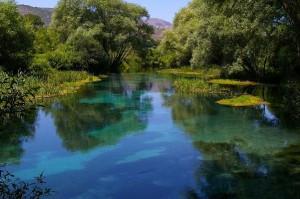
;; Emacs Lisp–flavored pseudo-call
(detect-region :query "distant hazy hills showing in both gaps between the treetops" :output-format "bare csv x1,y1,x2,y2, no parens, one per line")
18,5,172,40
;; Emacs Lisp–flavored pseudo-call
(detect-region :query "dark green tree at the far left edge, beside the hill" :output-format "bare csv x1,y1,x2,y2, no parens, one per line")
0,1,33,73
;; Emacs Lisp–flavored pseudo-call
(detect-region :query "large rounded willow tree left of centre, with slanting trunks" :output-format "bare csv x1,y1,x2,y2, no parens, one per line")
51,0,153,72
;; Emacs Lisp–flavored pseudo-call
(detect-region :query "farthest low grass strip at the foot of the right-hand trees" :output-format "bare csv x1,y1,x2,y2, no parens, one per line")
158,67,221,79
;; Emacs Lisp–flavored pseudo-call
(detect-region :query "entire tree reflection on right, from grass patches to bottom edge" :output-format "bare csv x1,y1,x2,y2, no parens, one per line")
164,94,300,199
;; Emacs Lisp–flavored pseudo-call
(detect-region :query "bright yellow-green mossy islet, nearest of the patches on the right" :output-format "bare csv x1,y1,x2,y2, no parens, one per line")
217,95,268,107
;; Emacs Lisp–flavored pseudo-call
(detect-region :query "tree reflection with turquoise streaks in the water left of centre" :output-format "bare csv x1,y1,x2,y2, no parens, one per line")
45,76,155,151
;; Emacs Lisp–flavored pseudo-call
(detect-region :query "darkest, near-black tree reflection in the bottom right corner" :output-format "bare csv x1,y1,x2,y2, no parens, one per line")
186,142,300,199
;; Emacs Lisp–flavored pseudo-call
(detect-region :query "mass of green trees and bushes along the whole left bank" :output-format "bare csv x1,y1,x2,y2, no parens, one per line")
0,0,153,76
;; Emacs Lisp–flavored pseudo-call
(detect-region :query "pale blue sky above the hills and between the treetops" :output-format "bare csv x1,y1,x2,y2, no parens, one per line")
17,0,190,22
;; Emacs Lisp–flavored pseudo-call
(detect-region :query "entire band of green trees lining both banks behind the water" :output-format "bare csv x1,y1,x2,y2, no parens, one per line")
0,0,300,82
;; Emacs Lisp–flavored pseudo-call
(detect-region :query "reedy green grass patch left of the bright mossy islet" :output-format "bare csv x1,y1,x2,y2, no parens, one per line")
173,79,231,96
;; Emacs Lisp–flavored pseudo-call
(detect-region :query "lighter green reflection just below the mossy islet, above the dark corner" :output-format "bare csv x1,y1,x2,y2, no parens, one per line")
165,92,300,155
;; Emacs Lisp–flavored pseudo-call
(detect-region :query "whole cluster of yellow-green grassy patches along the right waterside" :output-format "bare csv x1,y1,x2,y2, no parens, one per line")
158,67,267,107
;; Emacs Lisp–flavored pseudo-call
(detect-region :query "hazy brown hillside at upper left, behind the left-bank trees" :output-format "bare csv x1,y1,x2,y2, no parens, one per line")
18,5,53,26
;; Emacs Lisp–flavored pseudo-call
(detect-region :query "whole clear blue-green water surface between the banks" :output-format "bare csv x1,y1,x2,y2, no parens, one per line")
0,74,300,199
